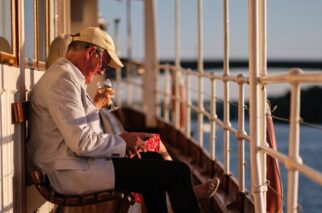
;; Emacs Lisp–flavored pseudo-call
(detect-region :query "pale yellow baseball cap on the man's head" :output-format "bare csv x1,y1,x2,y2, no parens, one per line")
73,27,123,68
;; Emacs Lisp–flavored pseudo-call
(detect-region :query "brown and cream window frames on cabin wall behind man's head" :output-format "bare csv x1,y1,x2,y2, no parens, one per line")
0,0,63,70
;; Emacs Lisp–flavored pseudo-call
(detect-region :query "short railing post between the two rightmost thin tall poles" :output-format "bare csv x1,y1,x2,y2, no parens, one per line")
209,73,217,160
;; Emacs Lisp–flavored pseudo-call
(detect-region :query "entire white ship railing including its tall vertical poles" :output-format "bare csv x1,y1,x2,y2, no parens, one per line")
119,0,322,212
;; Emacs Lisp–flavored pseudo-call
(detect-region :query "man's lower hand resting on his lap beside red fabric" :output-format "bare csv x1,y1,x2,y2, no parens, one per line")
120,132,153,158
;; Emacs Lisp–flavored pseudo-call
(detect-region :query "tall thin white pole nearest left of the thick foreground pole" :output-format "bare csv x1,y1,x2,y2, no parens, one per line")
224,0,230,174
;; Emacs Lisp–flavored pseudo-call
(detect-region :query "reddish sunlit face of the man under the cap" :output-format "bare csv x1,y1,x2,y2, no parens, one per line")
84,46,111,84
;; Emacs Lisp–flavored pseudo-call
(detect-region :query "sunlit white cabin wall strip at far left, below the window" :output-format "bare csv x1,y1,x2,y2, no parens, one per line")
0,64,37,212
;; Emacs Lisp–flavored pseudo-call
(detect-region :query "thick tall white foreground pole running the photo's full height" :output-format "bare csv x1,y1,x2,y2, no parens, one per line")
248,0,266,212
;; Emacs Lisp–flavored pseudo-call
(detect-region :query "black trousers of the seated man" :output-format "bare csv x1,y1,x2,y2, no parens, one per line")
113,152,200,213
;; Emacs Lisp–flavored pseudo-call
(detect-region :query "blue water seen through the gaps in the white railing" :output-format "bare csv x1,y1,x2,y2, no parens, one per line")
192,121,322,213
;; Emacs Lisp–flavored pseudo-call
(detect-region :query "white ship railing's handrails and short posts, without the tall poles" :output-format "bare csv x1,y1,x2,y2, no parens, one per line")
122,60,322,212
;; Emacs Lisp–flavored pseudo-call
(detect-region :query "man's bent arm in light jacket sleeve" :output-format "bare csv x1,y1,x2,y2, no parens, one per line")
47,74,126,157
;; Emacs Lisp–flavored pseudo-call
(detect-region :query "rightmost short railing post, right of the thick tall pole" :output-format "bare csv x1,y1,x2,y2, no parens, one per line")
287,69,302,213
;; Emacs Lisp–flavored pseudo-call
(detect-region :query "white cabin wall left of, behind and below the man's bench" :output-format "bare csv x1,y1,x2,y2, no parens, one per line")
0,64,54,213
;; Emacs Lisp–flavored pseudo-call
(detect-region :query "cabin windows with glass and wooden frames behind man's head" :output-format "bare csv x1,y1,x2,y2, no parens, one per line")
0,0,59,69
